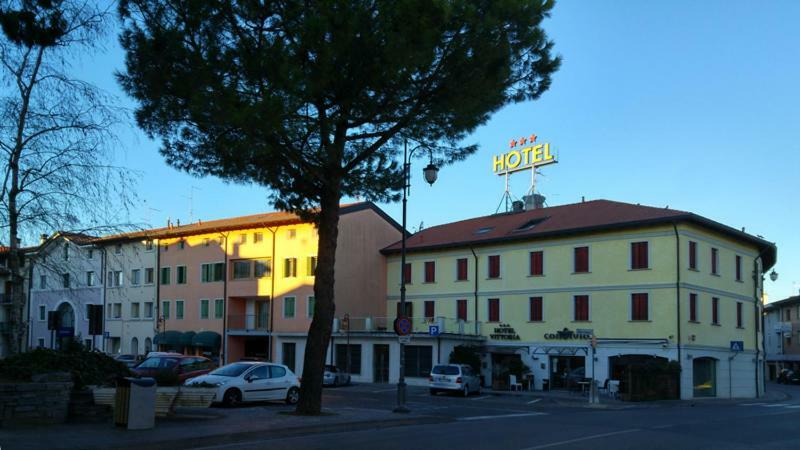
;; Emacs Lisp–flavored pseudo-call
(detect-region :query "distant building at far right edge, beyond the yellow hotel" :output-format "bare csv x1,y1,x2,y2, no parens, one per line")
764,295,800,380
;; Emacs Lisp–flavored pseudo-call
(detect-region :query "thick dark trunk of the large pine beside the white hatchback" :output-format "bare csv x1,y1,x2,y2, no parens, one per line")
296,188,341,415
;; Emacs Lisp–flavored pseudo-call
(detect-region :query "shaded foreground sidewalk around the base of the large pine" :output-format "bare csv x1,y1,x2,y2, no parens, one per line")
0,405,446,450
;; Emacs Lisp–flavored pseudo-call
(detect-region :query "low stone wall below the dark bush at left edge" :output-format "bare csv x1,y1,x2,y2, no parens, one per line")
0,381,72,429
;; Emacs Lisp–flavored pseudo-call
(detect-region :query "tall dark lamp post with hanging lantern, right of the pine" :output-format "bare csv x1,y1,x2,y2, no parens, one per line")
394,139,439,413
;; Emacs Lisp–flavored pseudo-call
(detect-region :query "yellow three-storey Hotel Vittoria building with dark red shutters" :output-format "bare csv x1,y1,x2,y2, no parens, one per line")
383,200,777,399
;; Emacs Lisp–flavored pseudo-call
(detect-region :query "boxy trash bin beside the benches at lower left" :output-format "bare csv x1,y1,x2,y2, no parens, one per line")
114,377,156,430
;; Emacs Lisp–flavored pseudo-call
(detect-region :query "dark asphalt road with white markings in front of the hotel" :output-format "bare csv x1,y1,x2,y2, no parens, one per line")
188,385,800,450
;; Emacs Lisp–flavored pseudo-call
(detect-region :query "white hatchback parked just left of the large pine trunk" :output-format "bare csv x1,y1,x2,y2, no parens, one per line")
184,361,300,406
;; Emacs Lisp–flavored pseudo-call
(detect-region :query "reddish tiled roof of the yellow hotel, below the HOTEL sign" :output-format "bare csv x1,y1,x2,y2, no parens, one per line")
383,200,776,268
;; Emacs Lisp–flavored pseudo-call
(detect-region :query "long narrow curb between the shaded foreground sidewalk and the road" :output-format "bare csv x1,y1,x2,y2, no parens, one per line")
104,416,454,450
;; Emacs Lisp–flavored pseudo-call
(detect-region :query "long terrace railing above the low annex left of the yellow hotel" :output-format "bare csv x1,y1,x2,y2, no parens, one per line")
333,317,482,336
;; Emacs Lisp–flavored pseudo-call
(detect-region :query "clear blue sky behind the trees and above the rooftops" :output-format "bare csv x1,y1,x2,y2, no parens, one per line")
72,0,800,300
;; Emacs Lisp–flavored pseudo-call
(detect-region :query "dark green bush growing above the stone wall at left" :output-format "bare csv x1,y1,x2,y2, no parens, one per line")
0,342,132,389
